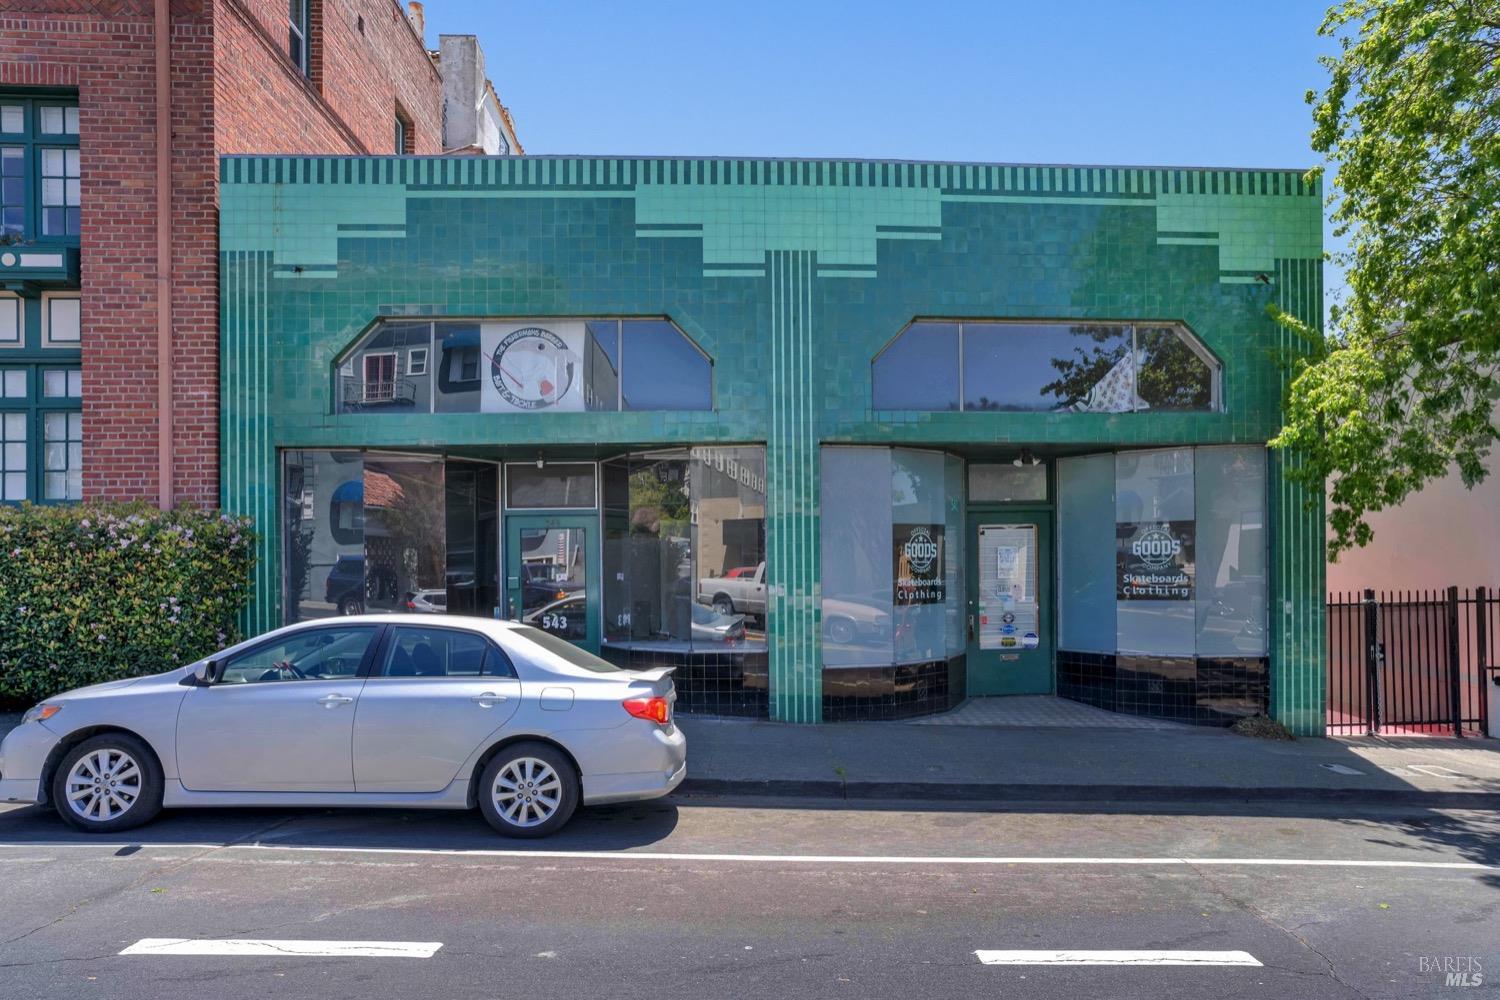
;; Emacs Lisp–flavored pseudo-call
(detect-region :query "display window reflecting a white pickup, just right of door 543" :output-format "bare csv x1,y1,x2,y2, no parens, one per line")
602,447,767,651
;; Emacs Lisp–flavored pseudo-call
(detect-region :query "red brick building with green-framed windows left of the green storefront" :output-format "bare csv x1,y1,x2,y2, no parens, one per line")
0,0,521,505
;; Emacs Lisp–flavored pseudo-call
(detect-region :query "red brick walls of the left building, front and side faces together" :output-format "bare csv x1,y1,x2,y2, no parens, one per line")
0,0,441,505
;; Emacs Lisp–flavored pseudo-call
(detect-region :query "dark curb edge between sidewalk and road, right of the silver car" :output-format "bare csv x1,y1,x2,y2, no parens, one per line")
672,778,1500,811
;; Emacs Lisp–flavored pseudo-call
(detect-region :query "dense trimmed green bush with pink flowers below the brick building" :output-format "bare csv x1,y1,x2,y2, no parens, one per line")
0,504,255,705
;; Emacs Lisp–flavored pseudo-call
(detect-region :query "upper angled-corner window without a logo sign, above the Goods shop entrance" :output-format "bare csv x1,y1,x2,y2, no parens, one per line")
872,321,1220,414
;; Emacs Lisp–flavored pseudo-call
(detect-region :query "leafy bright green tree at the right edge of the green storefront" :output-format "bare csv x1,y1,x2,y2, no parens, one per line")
1274,0,1500,555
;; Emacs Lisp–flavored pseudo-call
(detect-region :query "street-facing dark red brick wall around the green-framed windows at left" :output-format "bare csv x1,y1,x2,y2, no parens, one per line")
0,0,218,502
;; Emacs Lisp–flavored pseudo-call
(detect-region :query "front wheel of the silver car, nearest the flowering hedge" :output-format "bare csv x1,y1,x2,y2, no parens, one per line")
51,733,164,834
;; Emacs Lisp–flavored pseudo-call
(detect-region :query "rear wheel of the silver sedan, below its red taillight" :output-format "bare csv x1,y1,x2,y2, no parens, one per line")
479,744,579,838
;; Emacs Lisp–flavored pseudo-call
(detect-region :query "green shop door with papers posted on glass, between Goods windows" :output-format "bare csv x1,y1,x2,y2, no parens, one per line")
968,510,1053,697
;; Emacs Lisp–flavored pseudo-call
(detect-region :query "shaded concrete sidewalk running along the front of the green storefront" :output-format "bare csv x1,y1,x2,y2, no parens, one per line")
678,717,1500,810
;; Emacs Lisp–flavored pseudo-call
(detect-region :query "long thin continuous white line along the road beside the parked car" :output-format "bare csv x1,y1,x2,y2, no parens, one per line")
214,844,1500,871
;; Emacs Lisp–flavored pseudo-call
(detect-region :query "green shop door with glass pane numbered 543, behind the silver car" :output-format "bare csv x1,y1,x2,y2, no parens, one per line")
506,514,600,652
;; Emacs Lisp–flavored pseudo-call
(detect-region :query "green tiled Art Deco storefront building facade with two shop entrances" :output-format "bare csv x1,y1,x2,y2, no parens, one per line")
221,157,1325,733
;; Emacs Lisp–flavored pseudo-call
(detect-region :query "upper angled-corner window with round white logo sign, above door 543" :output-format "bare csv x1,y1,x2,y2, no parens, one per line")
333,319,714,414
